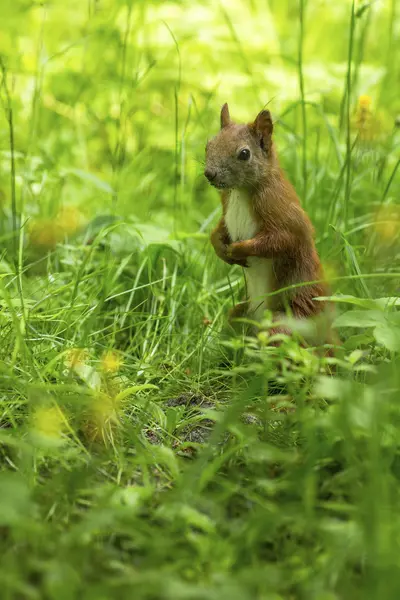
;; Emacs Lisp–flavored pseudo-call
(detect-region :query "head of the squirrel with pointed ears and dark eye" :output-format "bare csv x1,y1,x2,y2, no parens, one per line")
204,104,273,189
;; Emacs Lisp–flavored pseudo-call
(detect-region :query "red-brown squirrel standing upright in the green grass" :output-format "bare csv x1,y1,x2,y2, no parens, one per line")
204,104,334,343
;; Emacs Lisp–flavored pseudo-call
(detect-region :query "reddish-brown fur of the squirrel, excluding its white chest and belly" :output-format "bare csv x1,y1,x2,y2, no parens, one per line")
206,104,338,342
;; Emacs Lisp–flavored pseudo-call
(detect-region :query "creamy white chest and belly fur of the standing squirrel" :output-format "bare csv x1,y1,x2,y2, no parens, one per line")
225,190,272,319
